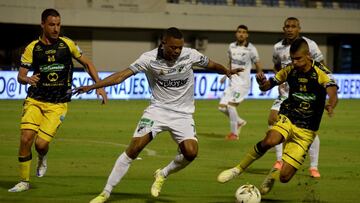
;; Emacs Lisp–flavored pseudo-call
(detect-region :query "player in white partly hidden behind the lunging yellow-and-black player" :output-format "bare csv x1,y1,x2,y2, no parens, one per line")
268,17,324,178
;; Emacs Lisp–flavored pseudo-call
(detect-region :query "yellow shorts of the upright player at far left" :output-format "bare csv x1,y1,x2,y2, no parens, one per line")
20,98,67,142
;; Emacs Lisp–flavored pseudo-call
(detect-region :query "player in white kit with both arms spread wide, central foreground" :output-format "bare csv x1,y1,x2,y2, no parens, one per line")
76,27,243,203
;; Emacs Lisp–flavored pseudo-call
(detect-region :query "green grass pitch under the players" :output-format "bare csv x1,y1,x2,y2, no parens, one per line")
0,100,360,203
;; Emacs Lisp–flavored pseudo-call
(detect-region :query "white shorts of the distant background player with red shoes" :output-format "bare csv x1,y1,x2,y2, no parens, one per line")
219,86,249,105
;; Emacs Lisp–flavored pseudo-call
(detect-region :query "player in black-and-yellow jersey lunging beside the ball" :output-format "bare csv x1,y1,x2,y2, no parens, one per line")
218,38,338,195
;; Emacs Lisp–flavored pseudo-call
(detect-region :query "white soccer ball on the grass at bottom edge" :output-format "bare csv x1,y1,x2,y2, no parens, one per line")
235,184,261,203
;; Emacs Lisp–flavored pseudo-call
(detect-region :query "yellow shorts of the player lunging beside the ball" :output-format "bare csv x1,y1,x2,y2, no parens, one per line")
271,114,316,169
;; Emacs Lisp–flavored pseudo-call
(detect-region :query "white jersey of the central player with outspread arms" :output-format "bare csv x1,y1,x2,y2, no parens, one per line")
129,47,209,114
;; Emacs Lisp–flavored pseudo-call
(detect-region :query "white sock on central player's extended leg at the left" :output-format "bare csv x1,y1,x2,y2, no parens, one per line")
104,152,132,195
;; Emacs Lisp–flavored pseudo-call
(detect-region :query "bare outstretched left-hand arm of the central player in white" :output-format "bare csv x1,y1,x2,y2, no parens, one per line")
75,68,134,94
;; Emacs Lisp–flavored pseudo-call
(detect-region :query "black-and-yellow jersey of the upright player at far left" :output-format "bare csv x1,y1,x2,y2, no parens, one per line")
21,37,82,103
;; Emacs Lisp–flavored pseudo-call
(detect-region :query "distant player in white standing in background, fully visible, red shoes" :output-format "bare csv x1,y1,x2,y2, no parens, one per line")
218,25,262,140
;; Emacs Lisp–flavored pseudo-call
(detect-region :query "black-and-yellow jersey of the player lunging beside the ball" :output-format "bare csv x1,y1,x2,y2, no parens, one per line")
274,61,337,131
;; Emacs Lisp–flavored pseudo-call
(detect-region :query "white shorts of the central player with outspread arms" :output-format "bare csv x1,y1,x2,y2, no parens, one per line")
133,106,197,144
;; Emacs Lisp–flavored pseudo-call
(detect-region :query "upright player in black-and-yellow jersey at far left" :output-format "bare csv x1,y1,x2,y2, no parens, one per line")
9,9,107,192
